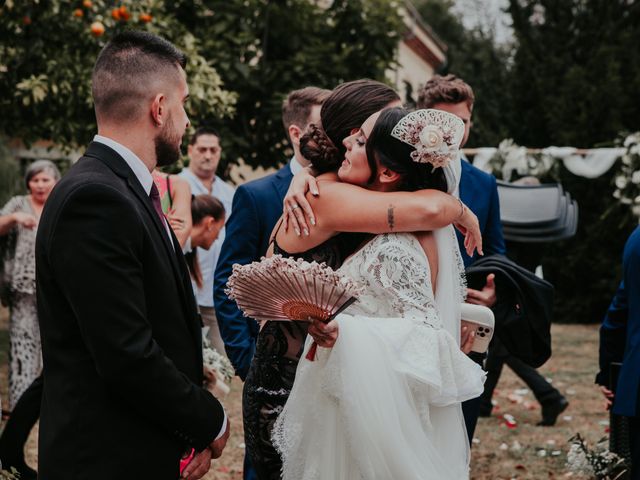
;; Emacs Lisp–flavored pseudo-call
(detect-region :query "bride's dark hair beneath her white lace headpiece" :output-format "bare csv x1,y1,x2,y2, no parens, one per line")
366,108,447,192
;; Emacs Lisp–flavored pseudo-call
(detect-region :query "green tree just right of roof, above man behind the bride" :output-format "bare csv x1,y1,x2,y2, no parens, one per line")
416,0,512,147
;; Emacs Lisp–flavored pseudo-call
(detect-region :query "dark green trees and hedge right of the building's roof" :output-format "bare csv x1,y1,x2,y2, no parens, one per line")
416,0,640,323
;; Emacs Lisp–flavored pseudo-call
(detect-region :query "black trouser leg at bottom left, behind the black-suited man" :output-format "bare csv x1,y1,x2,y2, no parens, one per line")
0,374,44,469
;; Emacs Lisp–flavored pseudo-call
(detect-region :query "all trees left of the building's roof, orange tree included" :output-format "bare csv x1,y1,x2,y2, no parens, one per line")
0,0,403,172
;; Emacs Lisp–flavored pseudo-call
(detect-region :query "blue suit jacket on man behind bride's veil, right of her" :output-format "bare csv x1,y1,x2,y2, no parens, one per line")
456,160,506,267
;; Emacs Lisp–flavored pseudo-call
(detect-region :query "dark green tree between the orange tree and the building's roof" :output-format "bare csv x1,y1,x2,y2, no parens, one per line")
174,0,403,172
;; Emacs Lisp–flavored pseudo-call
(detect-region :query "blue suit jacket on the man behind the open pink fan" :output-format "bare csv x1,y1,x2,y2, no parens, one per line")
213,165,293,380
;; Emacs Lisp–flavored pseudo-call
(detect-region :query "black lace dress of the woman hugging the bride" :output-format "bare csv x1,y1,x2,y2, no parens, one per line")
242,234,365,480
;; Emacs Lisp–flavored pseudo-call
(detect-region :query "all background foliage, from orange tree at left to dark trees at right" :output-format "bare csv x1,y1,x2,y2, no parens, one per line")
0,0,640,322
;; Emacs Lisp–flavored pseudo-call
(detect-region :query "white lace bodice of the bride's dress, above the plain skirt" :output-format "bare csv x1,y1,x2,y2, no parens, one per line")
340,233,442,328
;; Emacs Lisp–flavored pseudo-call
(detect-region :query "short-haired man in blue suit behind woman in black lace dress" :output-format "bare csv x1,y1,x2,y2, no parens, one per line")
213,87,330,479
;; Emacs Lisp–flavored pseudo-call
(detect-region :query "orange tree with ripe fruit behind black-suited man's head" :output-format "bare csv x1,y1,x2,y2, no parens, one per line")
0,0,235,152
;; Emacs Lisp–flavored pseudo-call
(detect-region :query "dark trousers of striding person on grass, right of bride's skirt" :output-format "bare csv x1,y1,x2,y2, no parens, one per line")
480,338,562,413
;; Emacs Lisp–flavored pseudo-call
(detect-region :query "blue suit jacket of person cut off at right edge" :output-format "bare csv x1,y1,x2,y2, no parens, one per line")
596,227,640,417
